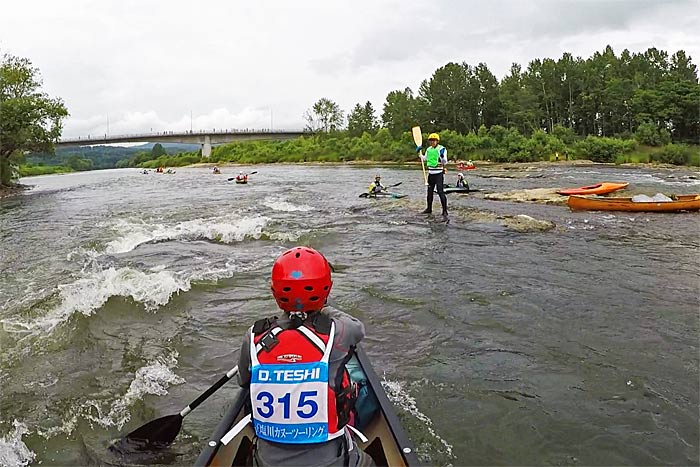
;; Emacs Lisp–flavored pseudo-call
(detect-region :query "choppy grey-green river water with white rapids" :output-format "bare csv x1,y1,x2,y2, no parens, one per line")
0,165,700,465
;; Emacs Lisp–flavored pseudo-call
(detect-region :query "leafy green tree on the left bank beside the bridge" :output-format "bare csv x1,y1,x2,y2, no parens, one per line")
0,55,68,185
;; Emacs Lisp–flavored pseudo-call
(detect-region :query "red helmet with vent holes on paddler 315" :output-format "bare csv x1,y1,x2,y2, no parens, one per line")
270,246,333,311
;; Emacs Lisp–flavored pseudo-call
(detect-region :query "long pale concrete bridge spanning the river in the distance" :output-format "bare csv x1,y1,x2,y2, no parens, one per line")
55,128,311,157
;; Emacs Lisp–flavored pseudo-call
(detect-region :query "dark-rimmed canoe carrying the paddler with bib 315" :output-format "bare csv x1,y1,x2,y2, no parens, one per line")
194,347,420,466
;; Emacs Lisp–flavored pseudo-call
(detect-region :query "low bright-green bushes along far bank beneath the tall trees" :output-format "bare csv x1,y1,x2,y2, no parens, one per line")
127,129,700,168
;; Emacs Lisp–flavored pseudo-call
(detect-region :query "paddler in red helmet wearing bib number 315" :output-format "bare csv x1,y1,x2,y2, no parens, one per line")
238,246,372,466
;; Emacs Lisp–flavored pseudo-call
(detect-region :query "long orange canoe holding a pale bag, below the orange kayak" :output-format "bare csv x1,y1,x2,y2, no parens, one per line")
567,194,700,212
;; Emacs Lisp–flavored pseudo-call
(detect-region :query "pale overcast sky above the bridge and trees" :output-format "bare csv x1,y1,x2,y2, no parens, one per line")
0,0,700,137
